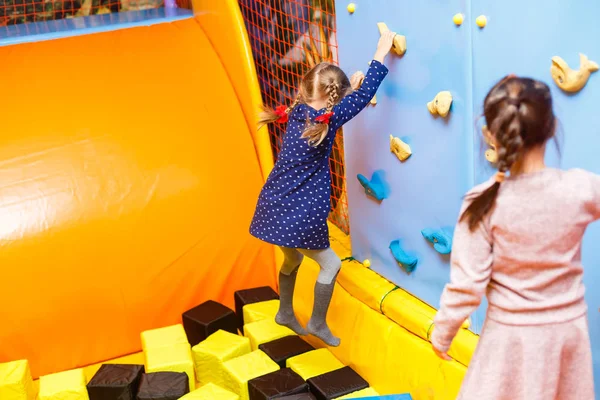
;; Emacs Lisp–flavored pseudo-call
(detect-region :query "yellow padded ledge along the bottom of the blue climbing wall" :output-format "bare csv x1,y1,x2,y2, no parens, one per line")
294,225,477,400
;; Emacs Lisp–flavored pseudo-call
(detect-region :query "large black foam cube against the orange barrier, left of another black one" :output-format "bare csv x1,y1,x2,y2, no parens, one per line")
182,300,238,346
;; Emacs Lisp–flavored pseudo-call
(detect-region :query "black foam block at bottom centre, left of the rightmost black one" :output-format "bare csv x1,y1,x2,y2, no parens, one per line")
248,368,308,400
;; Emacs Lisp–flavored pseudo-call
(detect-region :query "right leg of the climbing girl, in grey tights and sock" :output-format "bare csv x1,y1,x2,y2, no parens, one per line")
300,248,342,346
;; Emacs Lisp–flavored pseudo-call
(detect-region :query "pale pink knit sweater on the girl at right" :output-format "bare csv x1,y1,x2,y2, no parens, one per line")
431,168,600,351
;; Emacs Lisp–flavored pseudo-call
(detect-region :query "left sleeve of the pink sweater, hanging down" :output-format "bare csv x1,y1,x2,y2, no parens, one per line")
431,200,492,354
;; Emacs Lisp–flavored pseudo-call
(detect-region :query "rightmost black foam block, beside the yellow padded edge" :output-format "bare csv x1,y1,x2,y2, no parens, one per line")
307,367,369,400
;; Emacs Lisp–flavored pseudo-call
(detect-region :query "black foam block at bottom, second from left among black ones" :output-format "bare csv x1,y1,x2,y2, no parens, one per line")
137,372,190,400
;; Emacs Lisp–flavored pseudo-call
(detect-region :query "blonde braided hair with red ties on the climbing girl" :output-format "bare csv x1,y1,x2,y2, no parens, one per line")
258,63,352,147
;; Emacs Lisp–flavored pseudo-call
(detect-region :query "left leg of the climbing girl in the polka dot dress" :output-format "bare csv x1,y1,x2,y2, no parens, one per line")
275,247,307,335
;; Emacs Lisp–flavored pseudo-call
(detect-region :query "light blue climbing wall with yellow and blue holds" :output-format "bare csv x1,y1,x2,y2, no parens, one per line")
336,0,600,385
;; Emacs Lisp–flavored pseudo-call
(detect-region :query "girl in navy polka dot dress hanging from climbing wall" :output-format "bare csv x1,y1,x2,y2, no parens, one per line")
250,32,395,346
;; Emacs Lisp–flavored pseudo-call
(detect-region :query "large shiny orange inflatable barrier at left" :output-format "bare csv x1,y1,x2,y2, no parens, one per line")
0,19,275,377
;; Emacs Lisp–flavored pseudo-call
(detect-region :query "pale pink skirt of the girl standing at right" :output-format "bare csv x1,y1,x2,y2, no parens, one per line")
457,316,594,400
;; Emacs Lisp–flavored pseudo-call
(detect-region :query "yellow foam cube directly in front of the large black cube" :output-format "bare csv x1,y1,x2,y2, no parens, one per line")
192,330,250,385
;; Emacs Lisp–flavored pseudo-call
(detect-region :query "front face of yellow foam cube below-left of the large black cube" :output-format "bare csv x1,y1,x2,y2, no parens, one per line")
146,343,196,390
